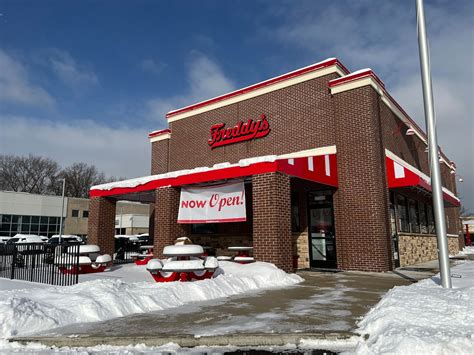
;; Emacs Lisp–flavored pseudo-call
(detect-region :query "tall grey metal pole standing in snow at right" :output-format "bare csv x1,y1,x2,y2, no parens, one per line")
416,0,451,288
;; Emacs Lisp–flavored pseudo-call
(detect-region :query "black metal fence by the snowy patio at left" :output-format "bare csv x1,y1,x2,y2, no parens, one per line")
0,243,79,286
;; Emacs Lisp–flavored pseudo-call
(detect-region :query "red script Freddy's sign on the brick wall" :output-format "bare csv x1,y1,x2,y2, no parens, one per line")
207,114,270,149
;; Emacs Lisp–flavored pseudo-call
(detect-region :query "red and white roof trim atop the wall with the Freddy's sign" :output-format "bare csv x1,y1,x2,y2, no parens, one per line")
166,58,349,118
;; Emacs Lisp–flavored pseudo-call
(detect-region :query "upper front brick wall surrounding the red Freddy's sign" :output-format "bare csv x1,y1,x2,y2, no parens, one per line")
165,74,337,171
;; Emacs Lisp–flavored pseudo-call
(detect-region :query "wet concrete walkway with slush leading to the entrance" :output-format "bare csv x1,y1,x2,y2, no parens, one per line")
25,272,411,343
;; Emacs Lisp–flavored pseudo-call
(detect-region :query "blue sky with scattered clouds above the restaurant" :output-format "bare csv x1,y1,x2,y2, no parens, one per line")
0,0,474,212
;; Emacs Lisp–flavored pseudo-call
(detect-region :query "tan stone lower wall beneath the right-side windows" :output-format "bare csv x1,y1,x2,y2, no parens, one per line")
398,234,459,267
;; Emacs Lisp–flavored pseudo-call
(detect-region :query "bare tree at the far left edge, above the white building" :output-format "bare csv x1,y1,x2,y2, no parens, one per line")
0,154,59,194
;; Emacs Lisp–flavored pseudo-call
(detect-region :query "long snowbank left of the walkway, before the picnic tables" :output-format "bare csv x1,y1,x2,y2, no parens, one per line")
0,262,303,338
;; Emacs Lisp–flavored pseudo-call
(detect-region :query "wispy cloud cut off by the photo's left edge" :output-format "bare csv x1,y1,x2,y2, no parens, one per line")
0,49,55,108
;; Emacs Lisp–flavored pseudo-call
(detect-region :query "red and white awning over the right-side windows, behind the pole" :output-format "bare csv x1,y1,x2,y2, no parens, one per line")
385,150,461,207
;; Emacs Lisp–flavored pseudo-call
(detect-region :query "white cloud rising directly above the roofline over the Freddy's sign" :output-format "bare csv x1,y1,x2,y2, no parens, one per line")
147,53,235,121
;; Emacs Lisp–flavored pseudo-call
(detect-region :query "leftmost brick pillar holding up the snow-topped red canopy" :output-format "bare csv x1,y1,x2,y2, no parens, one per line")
87,197,115,256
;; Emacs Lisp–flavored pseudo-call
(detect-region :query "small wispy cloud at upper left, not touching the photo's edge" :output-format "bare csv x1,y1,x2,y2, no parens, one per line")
48,49,99,89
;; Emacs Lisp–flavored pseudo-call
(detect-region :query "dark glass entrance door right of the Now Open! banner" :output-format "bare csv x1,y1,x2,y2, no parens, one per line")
308,190,337,269
